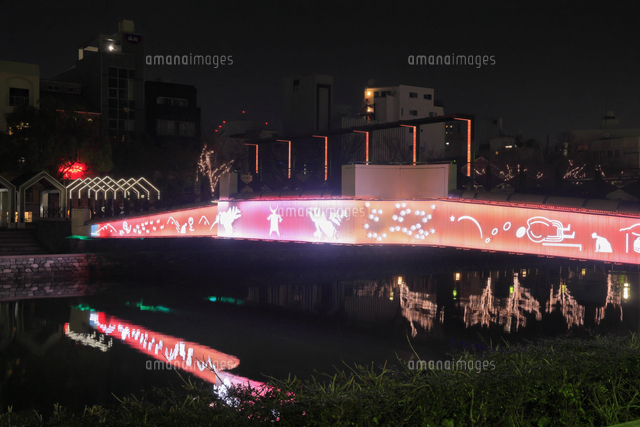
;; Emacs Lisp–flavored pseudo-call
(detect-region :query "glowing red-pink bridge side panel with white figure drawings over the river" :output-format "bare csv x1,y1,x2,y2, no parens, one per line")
85,187,640,264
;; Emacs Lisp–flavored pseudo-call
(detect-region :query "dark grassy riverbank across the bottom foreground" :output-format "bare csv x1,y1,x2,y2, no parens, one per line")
0,336,640,427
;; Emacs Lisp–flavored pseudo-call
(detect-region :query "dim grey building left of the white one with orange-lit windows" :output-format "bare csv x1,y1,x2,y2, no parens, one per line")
282,74,333,135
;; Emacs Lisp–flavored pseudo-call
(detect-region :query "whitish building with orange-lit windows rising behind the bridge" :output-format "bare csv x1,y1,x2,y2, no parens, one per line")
361,85,445,162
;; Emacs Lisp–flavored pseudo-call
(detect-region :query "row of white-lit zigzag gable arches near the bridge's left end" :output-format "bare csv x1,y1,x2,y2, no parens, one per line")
67,176,160,200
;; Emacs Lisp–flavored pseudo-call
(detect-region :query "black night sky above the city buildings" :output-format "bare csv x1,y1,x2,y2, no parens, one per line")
0,0,640,144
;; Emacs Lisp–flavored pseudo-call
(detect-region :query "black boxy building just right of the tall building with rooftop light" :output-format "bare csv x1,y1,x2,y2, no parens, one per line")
144,81,200,147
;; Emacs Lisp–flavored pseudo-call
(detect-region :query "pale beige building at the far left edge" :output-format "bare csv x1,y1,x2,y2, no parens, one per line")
0,61,40,133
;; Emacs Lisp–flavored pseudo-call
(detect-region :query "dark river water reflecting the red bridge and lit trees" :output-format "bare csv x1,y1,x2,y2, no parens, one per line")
0,252,640,413
